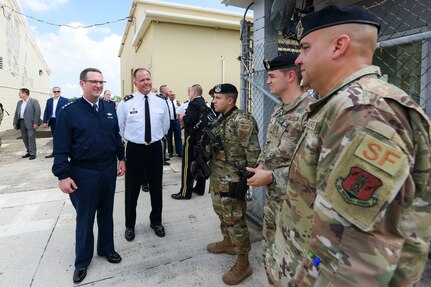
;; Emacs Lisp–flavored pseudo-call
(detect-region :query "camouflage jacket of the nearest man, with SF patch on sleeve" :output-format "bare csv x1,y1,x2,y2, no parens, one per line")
275,66,431,286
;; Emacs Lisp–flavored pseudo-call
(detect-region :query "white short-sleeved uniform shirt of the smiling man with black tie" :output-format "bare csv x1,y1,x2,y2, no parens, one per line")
117,92,170,144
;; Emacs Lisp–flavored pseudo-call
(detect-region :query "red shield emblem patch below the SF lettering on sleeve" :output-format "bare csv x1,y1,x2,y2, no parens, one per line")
336,166,382,207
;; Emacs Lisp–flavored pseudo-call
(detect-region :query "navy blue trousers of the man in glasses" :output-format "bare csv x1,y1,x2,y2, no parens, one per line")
70,161,117,268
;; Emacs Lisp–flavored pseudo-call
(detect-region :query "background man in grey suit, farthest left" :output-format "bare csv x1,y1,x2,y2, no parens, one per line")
13,88,41,160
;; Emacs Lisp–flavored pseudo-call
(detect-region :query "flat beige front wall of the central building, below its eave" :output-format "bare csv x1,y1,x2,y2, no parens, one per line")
152,23,240,101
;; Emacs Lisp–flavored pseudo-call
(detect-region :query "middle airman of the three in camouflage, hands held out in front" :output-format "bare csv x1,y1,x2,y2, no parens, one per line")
247,53,314,283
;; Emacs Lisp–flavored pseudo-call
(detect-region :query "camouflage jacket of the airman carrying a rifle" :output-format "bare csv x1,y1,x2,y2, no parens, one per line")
210,109,260,182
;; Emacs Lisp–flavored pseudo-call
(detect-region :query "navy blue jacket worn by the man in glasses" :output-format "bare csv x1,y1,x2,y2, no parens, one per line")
52,98,124,180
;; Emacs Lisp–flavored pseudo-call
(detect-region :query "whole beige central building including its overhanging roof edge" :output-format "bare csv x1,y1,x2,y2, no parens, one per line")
119,0,251,104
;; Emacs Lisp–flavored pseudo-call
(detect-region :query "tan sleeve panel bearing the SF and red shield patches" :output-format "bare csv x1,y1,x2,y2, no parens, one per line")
328,129,409,231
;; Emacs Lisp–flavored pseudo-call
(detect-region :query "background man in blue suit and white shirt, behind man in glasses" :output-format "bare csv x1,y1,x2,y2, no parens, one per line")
43,87,69,158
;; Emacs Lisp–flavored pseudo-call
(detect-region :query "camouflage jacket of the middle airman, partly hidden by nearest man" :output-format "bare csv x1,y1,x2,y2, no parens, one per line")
257,92,314,196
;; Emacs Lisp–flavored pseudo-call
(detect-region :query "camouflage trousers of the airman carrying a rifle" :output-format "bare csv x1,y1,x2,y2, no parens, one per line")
210,177,251,254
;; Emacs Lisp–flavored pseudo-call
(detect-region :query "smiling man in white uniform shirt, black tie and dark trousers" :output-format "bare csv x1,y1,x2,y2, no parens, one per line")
117,68,170,241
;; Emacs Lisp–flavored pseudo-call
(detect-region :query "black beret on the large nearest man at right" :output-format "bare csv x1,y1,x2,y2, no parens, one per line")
296,5,380,41
